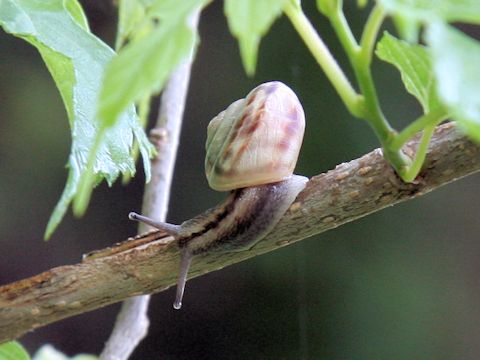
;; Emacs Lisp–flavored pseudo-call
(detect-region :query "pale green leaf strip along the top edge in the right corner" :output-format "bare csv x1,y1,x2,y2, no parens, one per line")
378,0,480,24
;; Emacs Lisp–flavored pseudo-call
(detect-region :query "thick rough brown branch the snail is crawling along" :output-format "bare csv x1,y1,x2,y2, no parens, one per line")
0,124,480,343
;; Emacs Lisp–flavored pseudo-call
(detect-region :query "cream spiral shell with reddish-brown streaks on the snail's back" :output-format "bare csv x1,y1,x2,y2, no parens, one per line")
205,81,305,191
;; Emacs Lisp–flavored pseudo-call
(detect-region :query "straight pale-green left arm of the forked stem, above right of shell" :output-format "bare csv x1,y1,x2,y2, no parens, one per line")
285,2,362,117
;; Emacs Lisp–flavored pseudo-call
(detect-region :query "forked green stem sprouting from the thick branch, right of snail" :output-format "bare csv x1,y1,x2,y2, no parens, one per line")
285,2,438,181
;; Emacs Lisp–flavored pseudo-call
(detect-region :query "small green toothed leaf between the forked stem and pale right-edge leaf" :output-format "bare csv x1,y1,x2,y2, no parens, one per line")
376,32,440,113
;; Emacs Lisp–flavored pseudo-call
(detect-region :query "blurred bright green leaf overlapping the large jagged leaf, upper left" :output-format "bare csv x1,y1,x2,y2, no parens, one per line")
98,1,203,132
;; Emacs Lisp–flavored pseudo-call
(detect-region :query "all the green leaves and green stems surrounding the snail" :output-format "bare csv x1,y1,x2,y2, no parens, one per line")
0,0,480,360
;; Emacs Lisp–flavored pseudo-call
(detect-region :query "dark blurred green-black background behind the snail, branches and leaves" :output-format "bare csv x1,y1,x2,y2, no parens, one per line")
0,0,480,359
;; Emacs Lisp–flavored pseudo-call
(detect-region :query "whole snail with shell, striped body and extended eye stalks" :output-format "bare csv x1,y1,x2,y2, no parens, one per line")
129,81,308,309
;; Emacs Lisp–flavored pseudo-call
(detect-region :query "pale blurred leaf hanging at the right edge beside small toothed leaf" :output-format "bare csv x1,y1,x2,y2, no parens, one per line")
426,22,480,142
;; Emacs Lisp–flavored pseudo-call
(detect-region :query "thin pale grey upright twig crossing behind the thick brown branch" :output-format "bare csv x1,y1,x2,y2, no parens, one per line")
100,11,200,360
